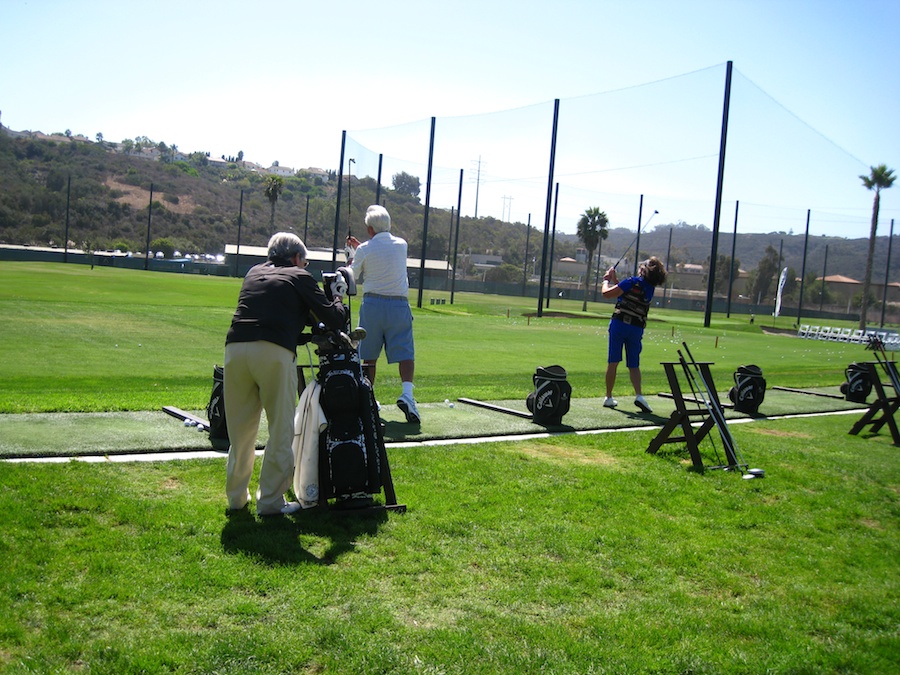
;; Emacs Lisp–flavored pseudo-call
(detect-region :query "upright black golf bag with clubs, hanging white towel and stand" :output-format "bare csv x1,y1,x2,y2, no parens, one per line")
293,267,406,512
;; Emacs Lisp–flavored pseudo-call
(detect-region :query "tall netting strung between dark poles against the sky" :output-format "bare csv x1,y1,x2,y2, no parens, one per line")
338,64,871,264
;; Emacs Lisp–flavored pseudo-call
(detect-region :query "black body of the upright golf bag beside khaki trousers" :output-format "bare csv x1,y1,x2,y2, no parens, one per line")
317,336,384,499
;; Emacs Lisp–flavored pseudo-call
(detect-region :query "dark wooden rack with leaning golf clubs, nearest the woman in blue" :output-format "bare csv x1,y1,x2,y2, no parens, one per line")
647,342,766,480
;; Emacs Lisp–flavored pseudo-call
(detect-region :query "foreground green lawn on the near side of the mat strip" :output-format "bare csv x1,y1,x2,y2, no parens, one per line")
0,416,900,675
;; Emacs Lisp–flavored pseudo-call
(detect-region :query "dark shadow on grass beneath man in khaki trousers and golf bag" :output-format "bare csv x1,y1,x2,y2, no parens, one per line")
220,507,387,566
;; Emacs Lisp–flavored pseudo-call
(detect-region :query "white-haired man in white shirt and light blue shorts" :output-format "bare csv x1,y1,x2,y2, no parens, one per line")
347,205,421,424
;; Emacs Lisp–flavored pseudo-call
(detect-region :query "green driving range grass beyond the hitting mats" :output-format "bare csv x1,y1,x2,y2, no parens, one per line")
0,262,880,413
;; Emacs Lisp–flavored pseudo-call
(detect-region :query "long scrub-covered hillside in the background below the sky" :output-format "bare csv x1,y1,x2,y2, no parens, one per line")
0,133,884,288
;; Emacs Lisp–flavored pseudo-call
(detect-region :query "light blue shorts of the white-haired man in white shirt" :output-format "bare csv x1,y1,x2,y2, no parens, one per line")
358,295,416,363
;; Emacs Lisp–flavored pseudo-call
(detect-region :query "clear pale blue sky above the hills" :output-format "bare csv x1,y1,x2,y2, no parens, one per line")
0,0,900,237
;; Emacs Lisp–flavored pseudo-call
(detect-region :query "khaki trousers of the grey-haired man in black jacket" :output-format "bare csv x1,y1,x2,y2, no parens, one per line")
225,340,297,515
